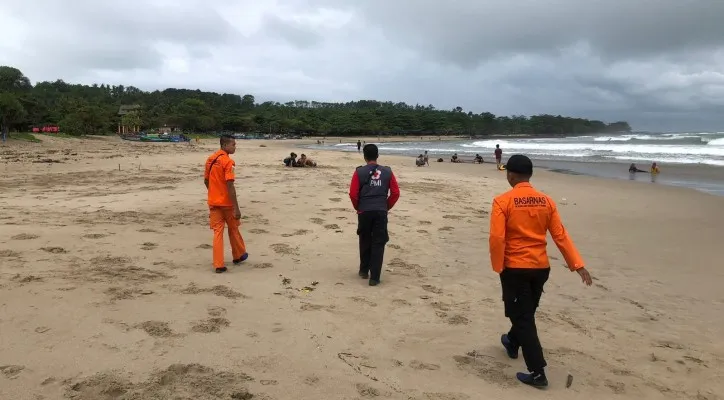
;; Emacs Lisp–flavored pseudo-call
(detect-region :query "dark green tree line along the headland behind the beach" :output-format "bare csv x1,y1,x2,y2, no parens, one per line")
0,66,631,141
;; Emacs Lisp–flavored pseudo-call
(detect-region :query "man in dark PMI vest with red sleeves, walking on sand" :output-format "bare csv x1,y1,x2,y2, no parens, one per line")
349,144,400,286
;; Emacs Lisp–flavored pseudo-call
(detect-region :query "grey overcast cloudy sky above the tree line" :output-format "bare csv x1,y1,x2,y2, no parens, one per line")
0,0,724,131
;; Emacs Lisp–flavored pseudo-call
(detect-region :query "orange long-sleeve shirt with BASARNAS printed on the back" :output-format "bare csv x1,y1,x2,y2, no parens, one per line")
489,183,584,273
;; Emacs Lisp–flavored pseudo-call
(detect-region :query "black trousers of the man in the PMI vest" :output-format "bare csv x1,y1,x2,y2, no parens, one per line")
357,211,390,281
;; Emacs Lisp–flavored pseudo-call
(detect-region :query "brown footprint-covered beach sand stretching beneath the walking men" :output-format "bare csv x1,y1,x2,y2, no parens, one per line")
0,137,724,400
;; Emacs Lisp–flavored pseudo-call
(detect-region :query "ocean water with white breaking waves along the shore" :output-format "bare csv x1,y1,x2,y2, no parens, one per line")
309,132,724,195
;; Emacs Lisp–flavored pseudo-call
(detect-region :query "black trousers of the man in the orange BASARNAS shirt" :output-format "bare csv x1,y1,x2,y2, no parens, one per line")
500,268,551,372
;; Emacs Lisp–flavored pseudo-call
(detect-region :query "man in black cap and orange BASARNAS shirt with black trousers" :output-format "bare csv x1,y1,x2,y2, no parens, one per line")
489,154,591,388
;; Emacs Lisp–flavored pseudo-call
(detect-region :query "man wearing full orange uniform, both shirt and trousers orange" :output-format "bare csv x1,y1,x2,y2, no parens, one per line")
204,135,249,273
